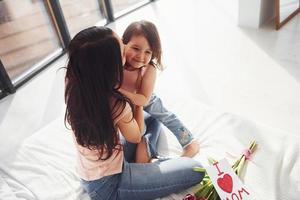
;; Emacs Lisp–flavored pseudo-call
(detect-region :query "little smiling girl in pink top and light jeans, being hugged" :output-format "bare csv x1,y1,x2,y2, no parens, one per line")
120,21,199,157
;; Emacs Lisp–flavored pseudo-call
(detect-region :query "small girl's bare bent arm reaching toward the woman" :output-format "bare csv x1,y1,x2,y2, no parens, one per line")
120,64,156,106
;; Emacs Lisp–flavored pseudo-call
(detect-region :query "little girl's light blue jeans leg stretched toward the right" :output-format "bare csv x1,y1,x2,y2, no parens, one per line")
144,94,194,148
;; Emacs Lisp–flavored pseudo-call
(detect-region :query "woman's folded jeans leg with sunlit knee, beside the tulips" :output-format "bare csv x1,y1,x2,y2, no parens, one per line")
118,157,204,200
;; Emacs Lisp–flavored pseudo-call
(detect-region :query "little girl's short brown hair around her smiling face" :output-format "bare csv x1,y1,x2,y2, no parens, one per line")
122,20,163,70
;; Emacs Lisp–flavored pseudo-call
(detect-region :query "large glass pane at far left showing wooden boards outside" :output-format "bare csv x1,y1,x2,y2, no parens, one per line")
0,0,61,80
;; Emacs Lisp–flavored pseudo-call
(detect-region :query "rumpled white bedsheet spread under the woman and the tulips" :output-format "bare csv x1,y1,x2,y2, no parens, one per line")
0,101,300,200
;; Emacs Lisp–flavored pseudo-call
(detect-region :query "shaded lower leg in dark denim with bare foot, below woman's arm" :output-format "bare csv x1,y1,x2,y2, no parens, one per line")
135,116,161,163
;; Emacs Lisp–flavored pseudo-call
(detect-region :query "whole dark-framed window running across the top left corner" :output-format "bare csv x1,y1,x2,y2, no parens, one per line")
0,0,154,99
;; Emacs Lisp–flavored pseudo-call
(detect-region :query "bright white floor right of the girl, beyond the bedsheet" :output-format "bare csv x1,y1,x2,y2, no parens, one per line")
111,0,300,134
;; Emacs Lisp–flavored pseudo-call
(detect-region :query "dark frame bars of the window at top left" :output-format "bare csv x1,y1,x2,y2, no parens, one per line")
0,0,156,99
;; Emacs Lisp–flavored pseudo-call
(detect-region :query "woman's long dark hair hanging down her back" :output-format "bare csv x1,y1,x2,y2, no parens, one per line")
65,26,131,160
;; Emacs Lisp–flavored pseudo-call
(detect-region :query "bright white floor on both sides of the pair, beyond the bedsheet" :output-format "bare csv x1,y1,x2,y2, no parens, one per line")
0,0,300,156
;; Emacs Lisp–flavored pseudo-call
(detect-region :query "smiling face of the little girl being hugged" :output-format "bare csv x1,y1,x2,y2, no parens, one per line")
125,35,152,69
